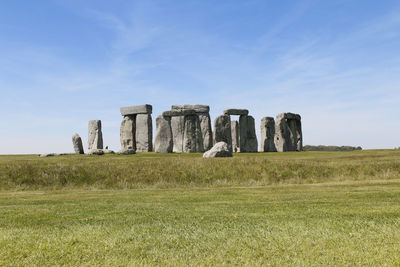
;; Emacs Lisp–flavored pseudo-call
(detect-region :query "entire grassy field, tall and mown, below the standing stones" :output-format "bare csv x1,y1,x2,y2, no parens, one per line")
0,150,400,266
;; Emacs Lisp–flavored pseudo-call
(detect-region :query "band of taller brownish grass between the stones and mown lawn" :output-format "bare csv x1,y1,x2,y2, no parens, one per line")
0,150,400,190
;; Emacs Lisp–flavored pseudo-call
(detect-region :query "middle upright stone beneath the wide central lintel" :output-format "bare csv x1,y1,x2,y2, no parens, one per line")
182,115,204,153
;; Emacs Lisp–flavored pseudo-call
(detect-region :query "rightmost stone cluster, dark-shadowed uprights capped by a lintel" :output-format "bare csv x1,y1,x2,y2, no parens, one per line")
274,113,303,152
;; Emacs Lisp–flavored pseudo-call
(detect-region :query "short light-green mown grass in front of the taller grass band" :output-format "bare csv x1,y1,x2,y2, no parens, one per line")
0,179,400,266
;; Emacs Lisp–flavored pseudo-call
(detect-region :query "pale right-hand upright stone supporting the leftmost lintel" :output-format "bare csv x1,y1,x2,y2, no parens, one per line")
136,114,153,152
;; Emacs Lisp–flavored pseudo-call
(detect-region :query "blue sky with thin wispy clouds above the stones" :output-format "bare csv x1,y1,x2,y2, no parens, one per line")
0,0,400,154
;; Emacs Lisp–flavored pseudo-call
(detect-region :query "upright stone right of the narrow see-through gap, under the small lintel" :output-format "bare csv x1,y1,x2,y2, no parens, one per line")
239,115,258,152
